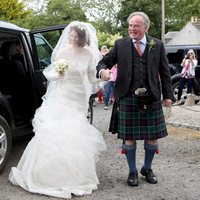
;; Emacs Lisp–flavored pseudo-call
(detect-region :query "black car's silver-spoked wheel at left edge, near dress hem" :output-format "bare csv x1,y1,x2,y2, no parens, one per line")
0,116,12,173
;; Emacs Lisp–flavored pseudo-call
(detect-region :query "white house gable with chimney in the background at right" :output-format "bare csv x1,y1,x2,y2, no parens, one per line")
165,17,200,45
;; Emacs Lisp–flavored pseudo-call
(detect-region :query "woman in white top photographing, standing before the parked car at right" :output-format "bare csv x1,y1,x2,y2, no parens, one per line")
173,49,197,106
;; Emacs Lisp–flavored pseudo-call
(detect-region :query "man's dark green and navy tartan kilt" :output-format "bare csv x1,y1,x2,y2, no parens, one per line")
109,94,168,140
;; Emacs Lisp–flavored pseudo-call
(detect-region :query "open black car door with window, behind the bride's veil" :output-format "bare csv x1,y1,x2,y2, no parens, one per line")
30,25,66,108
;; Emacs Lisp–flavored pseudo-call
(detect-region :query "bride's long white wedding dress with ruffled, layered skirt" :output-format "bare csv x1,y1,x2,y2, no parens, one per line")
9,47,106,198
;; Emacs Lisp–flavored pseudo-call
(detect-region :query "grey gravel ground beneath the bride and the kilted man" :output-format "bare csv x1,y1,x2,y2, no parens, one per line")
0,104,200,200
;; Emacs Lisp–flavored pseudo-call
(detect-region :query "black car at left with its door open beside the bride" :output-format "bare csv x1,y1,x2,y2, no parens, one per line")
0,21,93,173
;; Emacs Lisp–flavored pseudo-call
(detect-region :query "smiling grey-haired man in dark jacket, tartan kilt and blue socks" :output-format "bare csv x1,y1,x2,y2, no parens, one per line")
97,12,172,186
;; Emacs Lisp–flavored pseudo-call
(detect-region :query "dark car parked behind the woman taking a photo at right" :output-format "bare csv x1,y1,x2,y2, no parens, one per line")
165,45,200,101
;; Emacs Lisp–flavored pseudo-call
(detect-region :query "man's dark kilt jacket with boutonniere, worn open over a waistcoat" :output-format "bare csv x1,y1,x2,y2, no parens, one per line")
97,35,172,101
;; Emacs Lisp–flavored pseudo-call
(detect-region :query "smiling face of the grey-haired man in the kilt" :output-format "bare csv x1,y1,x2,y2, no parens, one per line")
128,15,148,40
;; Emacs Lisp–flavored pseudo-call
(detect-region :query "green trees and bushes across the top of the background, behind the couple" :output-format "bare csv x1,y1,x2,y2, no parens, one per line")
0,0,200,47
